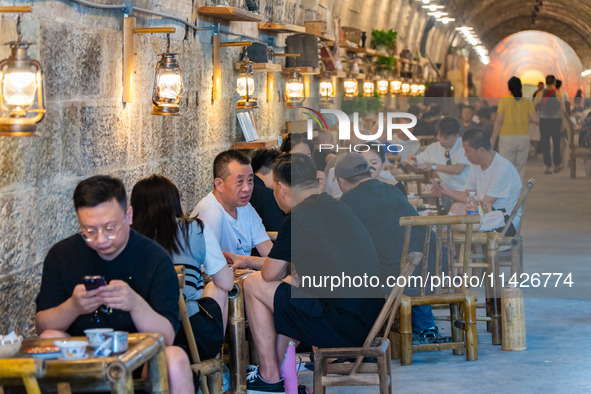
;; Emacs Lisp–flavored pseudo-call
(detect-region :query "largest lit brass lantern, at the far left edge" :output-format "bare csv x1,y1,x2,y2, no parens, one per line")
0,41,45,137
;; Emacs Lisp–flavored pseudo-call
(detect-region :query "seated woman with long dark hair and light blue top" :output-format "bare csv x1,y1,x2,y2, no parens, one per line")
131,174,234,360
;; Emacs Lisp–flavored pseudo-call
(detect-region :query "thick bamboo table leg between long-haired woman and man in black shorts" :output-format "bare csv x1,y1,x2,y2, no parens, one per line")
228,280,247,394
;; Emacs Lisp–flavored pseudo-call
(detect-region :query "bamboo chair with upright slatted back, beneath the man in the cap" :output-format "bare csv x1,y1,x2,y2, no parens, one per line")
394,215,480,365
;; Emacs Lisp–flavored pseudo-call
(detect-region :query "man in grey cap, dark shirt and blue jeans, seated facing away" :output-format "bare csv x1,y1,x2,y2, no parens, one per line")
335,153,445,339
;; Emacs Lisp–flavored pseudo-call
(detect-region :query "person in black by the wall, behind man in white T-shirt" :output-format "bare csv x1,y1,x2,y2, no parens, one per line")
250,148,285,231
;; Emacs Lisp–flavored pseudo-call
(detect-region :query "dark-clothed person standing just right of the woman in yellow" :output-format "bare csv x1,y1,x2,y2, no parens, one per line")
534,75,564,174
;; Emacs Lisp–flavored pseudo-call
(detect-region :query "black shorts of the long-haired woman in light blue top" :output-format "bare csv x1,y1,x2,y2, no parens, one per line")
174,297,224,360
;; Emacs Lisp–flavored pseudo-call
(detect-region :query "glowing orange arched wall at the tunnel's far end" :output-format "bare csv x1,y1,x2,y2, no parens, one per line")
482,31,584,97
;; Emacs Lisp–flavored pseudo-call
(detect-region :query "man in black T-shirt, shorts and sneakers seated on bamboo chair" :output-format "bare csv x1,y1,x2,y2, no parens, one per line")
236,154,383,392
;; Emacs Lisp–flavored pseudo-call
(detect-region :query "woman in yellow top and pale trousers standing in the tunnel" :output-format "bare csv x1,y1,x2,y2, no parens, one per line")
490,77,539,180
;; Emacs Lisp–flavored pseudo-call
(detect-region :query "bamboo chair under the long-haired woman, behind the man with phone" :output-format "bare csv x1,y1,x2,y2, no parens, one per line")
174,265,222,394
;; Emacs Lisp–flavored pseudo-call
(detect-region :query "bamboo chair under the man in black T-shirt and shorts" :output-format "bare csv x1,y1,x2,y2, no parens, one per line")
314,252,423,394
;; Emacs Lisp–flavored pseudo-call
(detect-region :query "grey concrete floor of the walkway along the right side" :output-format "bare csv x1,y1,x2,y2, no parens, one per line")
299,157,591,394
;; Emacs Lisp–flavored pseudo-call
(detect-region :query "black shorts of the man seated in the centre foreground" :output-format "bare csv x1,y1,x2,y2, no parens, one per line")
273,282,355,347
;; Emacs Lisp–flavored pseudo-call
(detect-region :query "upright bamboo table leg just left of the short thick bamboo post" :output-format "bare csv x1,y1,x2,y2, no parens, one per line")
486,231,502,345
